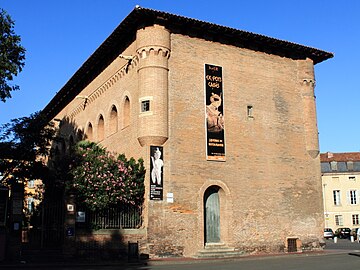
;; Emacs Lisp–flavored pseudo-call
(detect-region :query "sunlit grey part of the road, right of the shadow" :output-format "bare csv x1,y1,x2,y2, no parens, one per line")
143,239,360,270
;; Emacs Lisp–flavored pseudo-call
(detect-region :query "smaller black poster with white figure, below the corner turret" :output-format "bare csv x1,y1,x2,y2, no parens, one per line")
150,145,164,200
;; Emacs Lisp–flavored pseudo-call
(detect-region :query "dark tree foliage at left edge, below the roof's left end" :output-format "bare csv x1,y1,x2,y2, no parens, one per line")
0,112,56,184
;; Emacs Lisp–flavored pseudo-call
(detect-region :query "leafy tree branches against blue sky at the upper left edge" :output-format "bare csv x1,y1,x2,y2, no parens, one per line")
0,9,25,102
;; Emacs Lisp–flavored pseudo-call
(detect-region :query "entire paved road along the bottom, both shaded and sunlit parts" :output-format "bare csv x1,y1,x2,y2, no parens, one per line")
0,239,360,270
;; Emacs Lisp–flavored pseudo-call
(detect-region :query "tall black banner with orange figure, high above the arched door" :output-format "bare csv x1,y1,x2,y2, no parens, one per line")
205,64,225,161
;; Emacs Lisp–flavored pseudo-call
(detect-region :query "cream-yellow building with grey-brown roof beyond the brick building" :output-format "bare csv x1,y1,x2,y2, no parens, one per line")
320,152,360,231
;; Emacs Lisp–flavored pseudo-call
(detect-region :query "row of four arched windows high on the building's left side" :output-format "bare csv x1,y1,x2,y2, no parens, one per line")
85,96,130,141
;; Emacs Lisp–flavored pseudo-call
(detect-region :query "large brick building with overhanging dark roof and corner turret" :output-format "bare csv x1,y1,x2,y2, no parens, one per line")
44,7,333,257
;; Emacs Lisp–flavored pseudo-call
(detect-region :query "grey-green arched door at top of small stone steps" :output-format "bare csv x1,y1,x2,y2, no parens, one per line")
204,186,220,245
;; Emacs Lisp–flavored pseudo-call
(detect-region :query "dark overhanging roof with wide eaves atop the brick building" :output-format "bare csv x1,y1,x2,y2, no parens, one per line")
43,6,333,121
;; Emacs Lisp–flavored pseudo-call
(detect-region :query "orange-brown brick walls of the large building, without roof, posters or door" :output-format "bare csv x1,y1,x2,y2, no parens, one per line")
53,25,323,257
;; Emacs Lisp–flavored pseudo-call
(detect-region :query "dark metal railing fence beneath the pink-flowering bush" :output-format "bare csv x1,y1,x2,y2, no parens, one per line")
84,206,142,229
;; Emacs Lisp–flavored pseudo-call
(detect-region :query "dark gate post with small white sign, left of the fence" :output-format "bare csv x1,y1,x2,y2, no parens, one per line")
63,194,76,259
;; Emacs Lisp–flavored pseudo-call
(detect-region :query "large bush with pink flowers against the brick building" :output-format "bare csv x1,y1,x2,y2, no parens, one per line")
67,142,145,211
